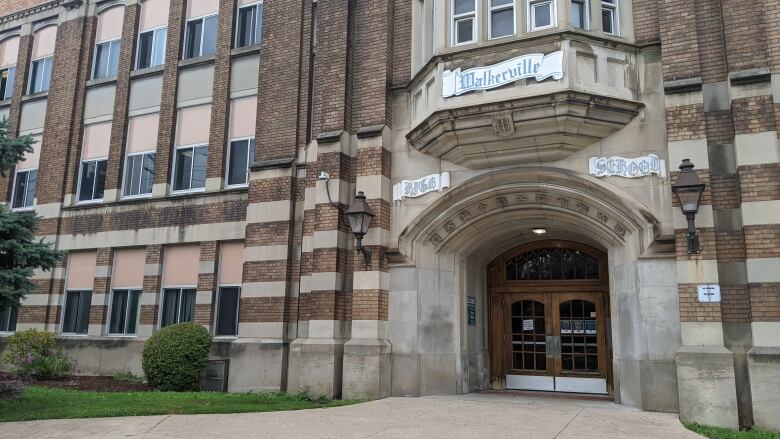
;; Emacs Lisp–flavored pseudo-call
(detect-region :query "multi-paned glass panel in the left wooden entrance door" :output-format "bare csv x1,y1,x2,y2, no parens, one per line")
512,300,547,372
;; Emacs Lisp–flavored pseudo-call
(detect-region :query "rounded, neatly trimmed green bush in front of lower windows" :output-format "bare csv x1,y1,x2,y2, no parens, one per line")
141,323,211,392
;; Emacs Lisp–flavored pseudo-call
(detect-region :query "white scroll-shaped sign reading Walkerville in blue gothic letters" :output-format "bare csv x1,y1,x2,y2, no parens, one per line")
441,50,563,98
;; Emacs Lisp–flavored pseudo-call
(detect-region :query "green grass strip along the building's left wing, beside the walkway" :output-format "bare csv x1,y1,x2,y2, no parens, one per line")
0,386,357,422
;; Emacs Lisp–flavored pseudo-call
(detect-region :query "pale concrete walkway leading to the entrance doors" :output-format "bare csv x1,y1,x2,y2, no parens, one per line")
0,393,700,439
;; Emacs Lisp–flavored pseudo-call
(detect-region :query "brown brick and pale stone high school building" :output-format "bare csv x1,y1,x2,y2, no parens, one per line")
0,0,780,429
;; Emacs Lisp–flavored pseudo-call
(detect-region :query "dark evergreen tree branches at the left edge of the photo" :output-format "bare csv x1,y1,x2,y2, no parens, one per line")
0,120,62,310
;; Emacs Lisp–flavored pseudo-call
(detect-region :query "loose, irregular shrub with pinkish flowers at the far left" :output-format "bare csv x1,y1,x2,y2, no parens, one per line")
2,329,70,380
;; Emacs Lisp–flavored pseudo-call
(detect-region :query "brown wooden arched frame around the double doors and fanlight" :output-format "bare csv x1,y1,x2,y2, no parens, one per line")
487,240,613,394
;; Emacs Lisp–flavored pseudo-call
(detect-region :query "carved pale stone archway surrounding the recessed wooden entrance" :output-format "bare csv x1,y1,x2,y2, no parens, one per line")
391,167,679,410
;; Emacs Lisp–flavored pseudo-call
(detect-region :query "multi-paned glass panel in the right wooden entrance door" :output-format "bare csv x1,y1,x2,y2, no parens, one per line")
560,300,599,374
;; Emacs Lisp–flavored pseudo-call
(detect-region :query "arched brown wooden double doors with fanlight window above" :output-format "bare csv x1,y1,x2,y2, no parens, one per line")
488,240,612,394
